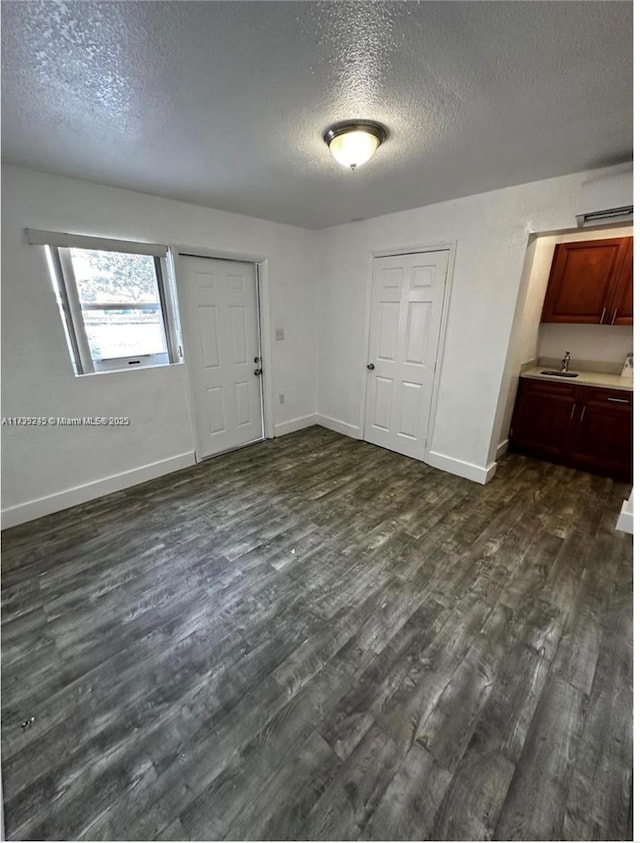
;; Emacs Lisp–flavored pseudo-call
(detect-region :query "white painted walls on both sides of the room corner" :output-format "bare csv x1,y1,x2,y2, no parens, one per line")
2,162,625,526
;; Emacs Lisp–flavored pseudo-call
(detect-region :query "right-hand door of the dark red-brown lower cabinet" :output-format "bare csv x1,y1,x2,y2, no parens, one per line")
570,387,633,481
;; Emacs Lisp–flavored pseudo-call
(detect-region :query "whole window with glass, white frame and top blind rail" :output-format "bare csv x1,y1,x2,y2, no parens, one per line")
27,231,180,374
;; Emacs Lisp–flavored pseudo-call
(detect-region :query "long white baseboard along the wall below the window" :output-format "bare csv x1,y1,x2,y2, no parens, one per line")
2,451,195,530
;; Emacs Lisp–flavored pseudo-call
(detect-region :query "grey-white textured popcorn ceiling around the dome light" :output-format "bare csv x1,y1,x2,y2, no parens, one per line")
2,0,632,228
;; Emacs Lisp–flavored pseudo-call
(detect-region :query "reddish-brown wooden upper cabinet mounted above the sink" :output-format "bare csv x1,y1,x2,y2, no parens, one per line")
542,237,633,325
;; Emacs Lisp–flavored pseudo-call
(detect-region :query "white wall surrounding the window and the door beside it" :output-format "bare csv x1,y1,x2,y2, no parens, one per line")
2,167,317,526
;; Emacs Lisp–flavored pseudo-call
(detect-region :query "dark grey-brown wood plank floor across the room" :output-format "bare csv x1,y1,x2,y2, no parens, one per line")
2,428,632,840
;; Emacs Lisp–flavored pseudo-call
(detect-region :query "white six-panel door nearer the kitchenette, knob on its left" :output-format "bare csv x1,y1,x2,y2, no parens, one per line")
364,251,449,460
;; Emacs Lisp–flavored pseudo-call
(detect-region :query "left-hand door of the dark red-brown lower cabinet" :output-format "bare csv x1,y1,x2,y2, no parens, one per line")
511,378,577,460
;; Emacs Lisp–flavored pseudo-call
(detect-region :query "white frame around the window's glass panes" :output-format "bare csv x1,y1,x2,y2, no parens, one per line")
43,237,183,375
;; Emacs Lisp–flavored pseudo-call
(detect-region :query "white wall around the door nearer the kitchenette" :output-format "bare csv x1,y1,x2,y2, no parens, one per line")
317,168,624,480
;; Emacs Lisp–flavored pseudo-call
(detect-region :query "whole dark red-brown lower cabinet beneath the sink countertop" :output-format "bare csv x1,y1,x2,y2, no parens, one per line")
510,378,633,481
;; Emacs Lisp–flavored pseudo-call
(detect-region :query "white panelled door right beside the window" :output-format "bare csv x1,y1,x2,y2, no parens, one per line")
179,256,263,459
